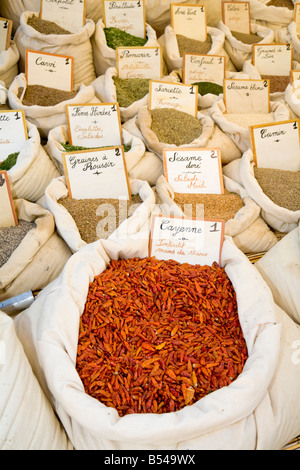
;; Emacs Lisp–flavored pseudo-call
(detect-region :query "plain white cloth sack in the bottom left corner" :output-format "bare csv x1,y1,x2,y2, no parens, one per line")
0,311,73,450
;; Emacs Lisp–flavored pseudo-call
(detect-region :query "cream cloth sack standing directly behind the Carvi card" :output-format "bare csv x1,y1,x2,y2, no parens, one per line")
14,11,96,87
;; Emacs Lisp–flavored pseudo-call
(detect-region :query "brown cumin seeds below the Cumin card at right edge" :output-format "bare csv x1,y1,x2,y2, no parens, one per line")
253,166,300,211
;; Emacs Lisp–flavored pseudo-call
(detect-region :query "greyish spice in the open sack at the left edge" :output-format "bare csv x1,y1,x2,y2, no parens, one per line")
0,219,36,268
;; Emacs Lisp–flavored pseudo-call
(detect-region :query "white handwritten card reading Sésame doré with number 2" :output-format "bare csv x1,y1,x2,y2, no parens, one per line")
163,148,224,194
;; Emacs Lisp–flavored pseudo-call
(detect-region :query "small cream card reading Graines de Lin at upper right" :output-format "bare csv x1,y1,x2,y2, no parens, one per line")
252,44,293,76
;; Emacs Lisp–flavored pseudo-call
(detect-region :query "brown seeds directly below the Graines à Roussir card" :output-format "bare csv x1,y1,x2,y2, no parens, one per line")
57,194,143,243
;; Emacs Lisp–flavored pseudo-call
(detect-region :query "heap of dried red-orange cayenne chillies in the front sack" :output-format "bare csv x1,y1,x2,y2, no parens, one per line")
76,258,248,416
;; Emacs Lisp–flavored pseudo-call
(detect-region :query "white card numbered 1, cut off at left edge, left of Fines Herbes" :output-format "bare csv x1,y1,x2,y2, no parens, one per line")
0,109,28,161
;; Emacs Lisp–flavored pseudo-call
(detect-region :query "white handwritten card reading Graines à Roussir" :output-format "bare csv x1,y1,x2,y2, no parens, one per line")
62,146,131,200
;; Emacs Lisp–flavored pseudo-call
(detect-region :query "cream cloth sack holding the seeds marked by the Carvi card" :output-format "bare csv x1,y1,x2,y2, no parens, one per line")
7,73,100,138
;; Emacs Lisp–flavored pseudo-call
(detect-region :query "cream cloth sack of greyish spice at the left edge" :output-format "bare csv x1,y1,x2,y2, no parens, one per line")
0,199,71,300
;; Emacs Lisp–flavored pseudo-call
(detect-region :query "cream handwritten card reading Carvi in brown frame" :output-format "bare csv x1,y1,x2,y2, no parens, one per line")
26,50,74,91
